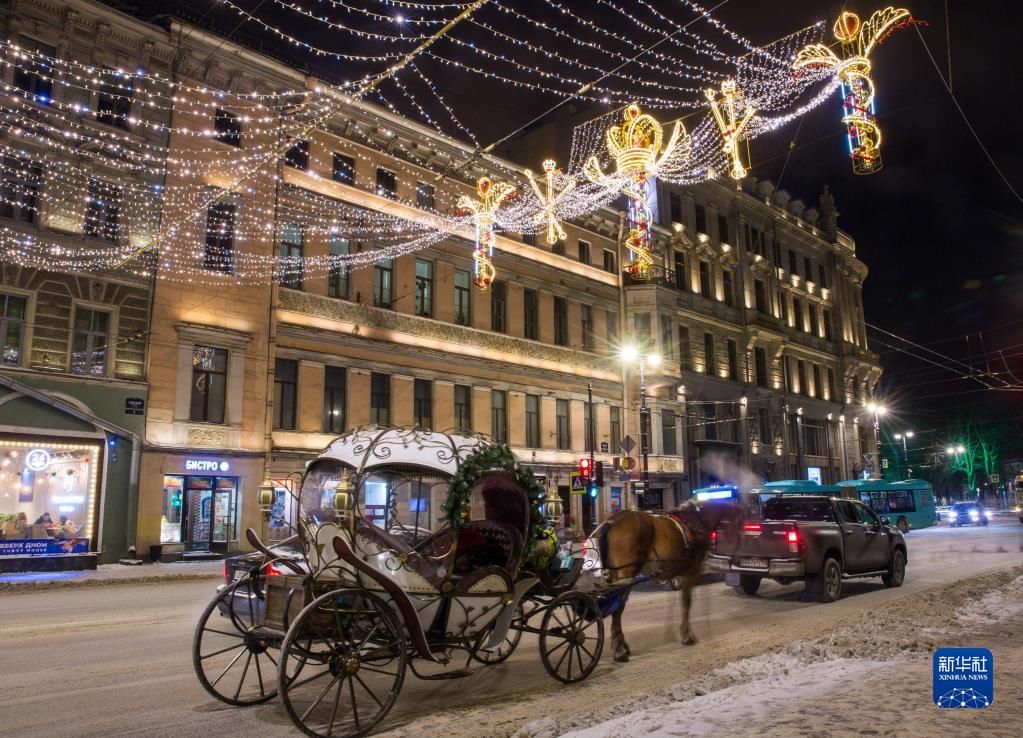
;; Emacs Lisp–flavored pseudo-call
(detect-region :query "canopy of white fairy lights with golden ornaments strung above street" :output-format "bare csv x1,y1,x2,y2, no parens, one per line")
0,0,911,290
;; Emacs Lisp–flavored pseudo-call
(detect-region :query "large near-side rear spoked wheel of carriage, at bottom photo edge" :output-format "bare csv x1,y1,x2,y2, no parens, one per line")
277,589,408,738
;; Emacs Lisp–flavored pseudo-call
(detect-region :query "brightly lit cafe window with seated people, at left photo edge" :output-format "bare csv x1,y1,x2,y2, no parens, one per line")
0,437,103,556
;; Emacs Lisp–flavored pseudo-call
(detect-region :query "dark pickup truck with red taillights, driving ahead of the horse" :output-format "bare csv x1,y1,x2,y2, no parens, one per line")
707,494,906,602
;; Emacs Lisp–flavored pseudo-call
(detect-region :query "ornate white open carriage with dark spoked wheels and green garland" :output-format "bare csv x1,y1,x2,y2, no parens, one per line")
193,427,607,736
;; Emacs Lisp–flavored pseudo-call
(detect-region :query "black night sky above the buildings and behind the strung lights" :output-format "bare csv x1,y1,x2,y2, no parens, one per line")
122,0,1023,458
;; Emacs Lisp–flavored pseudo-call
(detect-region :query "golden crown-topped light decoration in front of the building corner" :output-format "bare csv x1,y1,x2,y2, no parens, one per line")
583,103,690,279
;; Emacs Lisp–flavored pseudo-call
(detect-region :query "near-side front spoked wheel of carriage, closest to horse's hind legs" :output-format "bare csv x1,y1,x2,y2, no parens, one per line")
540,592,604,684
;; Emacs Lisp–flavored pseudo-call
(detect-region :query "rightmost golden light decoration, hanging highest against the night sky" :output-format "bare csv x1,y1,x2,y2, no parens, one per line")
793,6,911,174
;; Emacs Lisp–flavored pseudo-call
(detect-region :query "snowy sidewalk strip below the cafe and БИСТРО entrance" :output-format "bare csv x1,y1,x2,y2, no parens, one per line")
0,561,224,593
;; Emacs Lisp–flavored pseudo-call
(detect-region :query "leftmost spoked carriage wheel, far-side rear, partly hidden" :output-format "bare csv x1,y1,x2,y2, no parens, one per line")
192,576,280,706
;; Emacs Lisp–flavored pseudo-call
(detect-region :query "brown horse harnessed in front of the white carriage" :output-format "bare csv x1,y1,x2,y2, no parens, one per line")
594,501,743,661
